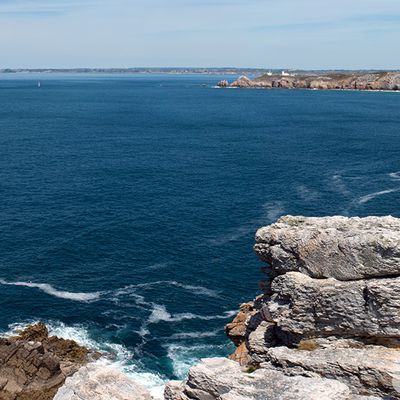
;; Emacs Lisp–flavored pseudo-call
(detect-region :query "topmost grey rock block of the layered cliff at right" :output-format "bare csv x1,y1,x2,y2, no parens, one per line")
255,216,400,281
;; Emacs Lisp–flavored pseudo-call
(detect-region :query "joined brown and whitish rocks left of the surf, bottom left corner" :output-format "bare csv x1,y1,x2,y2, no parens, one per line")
0,323,151,400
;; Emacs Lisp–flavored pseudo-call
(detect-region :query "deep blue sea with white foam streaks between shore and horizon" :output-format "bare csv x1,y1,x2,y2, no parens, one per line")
0,74,400,391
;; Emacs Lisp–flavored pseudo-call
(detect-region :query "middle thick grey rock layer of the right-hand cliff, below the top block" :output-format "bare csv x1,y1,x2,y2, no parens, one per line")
263,272,400,344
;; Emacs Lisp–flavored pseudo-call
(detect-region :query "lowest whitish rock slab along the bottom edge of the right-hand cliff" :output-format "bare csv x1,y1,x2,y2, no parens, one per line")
165,358,351,400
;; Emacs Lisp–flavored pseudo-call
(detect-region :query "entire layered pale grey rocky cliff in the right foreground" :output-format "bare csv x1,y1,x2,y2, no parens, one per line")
165,216,400,400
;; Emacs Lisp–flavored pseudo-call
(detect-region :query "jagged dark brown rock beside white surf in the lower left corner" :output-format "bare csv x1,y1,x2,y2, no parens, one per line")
0,324,96,400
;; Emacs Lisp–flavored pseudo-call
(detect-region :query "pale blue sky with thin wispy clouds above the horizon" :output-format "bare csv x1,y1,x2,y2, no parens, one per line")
0,0,400,69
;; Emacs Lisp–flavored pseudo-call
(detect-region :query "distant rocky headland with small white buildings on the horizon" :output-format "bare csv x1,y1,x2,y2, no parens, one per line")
218,71,400,90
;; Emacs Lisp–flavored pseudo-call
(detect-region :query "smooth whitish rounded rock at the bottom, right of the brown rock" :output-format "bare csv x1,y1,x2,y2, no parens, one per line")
54,363,151,400
